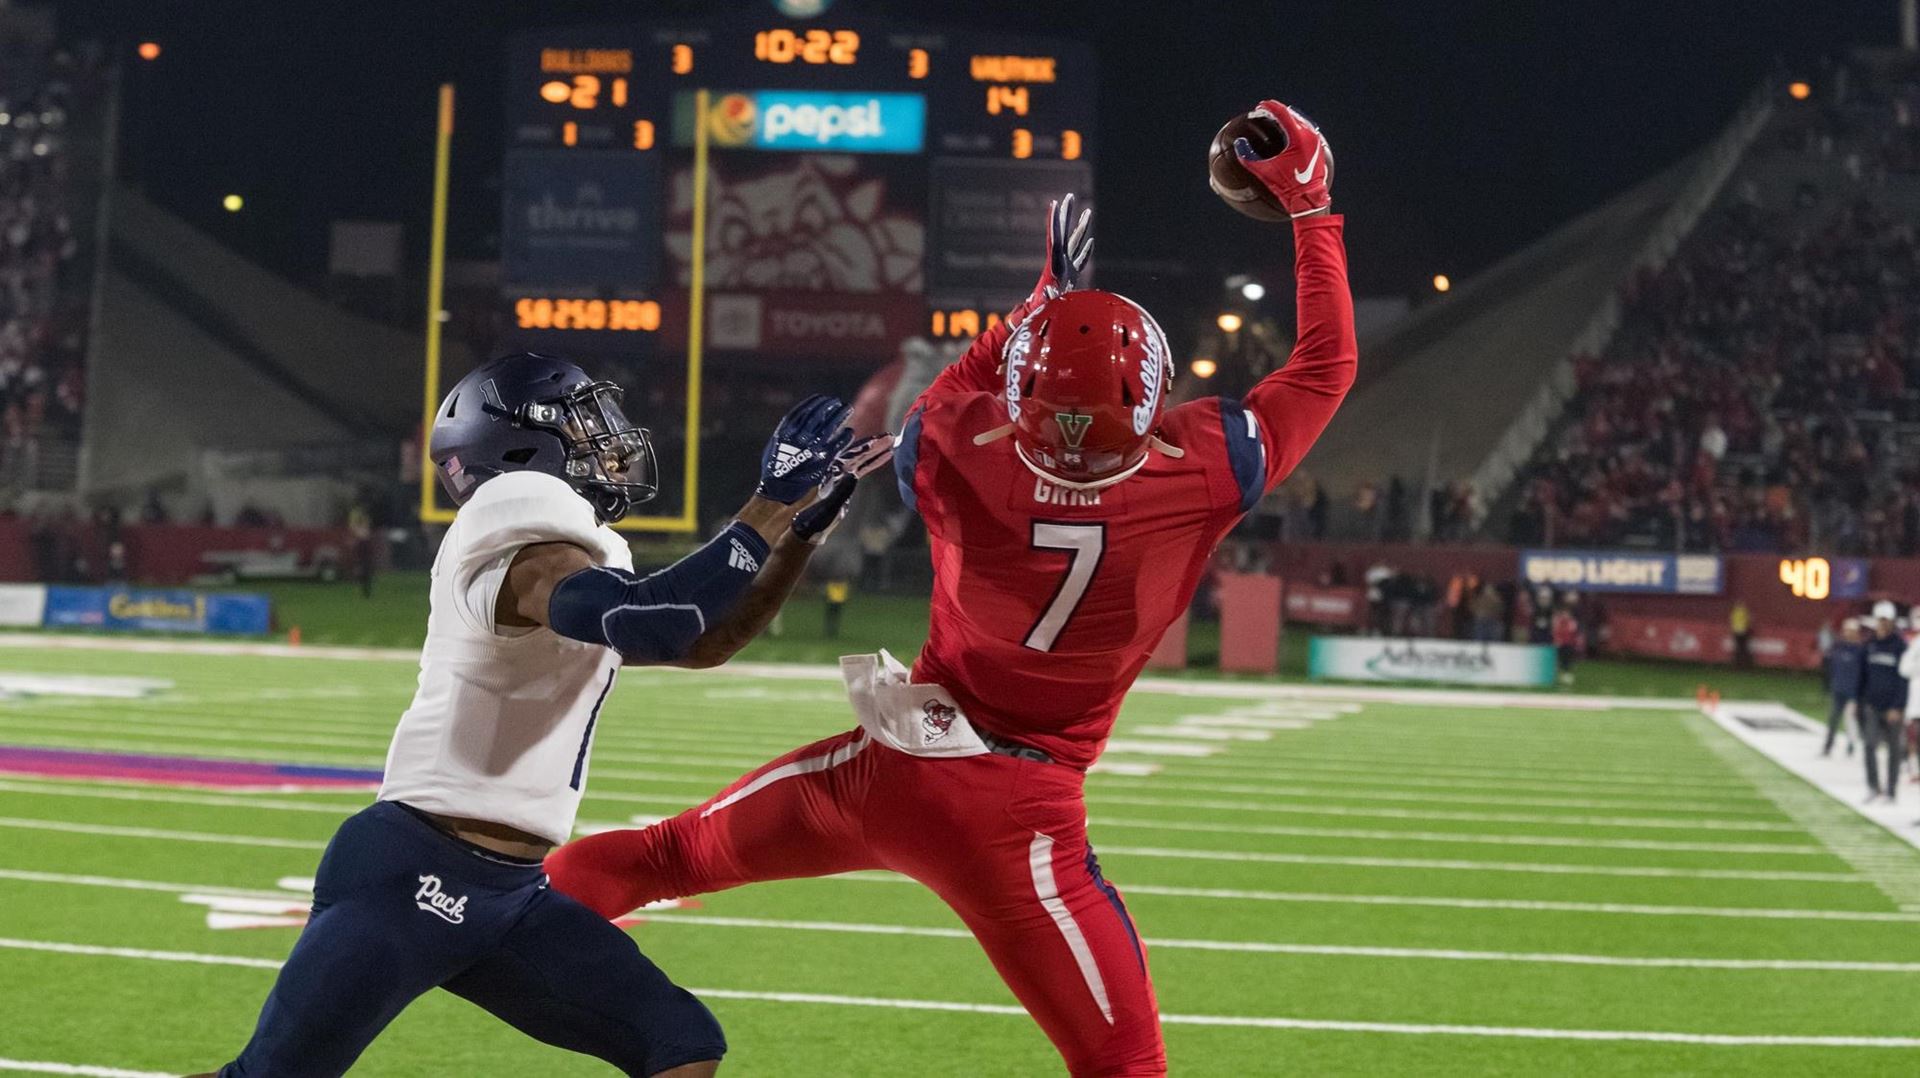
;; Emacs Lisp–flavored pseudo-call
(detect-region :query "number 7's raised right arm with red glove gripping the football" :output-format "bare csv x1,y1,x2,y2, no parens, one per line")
1229,100,1359,490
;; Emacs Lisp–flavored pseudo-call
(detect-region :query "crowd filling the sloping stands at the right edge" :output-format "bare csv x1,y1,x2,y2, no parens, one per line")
1507,63,1920,553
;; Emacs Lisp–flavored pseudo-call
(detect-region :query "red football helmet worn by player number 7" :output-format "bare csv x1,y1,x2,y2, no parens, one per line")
1004,288,1173,490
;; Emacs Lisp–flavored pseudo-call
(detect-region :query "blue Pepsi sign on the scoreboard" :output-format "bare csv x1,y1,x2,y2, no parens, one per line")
674,90,927,154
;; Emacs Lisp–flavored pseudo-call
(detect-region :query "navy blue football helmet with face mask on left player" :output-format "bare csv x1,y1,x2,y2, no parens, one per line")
428,352,660,523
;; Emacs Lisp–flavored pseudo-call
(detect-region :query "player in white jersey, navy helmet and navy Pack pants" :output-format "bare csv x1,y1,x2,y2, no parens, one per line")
206,354,891,1078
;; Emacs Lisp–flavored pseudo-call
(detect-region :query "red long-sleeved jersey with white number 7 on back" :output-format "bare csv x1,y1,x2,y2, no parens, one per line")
895,215,1356,767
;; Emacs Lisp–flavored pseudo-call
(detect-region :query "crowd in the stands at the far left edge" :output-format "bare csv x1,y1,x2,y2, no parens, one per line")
0,42,94,503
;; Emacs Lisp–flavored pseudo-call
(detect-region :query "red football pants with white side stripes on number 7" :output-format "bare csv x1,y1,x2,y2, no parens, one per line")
547,730,1167,1078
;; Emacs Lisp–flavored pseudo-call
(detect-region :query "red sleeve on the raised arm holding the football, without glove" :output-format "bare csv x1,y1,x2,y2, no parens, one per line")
1242,215,1359,490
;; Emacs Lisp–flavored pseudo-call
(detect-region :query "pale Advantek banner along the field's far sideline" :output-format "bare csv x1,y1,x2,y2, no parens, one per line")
1308,636,1555,686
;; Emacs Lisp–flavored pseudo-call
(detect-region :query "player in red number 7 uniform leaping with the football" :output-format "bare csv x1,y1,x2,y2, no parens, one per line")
547,102,1356,1076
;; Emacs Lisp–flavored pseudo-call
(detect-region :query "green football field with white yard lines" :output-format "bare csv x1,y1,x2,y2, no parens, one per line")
0,634,1920,1078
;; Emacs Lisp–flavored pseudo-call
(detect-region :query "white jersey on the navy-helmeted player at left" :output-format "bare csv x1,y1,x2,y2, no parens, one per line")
380,473,634,844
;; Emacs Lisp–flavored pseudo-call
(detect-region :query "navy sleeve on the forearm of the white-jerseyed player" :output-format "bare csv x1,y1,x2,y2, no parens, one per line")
547,521,770,663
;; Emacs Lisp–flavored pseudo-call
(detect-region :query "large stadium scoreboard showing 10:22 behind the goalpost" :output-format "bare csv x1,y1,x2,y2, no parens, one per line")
501,12,1094,365
